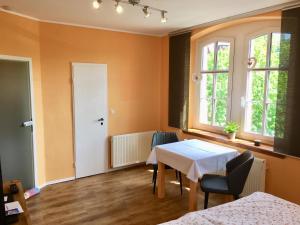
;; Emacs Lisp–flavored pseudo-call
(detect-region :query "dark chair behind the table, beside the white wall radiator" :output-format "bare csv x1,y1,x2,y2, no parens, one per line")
151,131,182,195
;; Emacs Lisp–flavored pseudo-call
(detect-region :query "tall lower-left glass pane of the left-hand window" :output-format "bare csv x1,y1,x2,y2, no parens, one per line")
199,74,213,124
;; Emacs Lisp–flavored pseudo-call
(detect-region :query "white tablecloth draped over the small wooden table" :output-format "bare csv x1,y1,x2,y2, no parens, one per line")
147,139,238,182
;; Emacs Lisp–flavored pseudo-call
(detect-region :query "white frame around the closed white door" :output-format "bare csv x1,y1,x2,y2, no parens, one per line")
71,62,109,179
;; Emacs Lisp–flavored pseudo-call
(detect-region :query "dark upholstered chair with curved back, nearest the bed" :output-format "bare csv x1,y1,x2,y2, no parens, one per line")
200,151,254,209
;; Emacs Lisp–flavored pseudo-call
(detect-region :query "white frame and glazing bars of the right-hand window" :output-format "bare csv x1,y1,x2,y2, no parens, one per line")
239,27,281,144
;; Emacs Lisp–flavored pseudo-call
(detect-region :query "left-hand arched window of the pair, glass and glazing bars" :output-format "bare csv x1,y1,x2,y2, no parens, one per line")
198,40,232,127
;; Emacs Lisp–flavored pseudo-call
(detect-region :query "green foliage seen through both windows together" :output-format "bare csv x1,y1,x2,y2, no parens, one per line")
201,33,290,136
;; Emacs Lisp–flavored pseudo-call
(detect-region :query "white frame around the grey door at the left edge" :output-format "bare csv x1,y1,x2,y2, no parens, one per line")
0,55,39,187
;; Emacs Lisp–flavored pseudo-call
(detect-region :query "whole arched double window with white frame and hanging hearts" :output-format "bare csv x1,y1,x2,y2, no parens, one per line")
190,20,290,144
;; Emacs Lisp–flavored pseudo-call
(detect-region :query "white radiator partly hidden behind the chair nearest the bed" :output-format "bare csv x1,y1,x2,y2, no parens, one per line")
241,158,266,196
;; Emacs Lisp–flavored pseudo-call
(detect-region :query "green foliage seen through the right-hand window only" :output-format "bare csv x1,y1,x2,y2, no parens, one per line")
249,33,289,136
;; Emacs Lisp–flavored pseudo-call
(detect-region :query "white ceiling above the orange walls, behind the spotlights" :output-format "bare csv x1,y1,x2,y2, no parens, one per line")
0,0,293,36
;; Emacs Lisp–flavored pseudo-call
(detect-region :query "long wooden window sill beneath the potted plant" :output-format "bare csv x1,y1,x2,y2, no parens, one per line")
183,129,285,158
